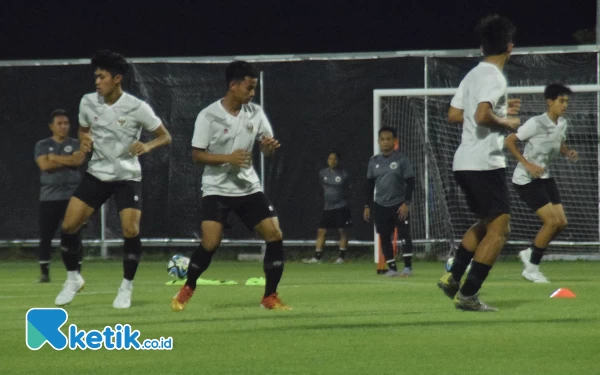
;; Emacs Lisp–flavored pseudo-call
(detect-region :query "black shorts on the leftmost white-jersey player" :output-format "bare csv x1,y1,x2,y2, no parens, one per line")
73,173,142,212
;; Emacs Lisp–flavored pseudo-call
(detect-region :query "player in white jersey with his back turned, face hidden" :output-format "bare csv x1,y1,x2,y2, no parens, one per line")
438,15,520,311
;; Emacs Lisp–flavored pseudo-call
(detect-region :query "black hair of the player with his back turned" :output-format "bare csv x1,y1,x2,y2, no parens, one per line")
476,14,517,56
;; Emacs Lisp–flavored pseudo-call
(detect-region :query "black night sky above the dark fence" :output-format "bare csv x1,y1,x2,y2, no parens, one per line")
0,0,596,60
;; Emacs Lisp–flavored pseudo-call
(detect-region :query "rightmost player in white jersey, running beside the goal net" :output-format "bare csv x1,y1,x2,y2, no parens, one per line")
504,83,578,283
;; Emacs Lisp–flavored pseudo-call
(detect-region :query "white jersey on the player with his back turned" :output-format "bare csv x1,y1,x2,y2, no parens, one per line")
450,62,508,171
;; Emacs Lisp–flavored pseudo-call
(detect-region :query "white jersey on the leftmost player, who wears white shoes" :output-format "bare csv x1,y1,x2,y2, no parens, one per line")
79,92,161,181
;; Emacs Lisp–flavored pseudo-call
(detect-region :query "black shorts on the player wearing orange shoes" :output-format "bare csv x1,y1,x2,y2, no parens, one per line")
202,191,277,230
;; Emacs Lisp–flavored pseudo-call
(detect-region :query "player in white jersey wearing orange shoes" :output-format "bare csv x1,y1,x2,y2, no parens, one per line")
171,61,289,311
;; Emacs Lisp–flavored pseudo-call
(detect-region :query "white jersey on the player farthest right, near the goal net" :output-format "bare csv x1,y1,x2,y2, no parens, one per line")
512,113,567,185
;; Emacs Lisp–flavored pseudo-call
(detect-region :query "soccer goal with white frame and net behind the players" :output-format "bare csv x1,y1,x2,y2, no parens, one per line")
373,85,600,262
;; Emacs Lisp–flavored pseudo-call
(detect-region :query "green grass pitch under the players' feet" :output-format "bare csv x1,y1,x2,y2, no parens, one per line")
0,261,600,375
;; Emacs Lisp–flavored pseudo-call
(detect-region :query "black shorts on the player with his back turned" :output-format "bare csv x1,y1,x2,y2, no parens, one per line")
454,168,510,218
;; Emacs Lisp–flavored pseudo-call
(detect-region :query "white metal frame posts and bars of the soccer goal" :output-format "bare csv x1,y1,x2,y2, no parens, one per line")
373,84,600,263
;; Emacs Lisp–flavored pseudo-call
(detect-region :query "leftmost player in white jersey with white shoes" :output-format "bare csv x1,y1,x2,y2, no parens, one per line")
55,51,171,308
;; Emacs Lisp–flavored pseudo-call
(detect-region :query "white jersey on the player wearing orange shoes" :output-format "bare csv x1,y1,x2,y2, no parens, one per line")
192,100,273,197
